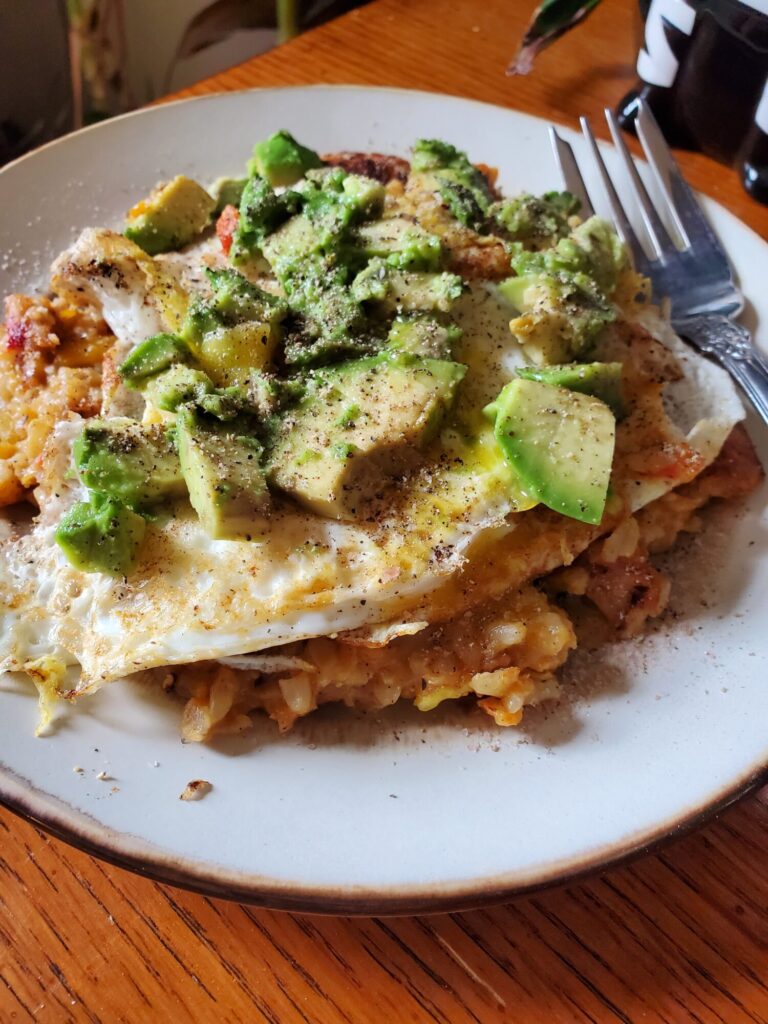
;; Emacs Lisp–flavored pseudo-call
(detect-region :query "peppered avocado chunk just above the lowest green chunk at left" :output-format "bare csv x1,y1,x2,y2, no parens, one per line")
72,417,184,511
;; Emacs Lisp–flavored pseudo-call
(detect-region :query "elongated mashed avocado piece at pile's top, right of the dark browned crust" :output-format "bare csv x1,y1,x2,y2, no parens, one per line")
411,138,494,229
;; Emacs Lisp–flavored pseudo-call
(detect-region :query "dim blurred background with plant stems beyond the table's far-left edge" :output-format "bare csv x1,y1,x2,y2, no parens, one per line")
0,0,366,165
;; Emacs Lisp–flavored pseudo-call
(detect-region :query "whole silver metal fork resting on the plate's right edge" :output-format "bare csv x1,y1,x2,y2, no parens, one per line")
550,102,768,423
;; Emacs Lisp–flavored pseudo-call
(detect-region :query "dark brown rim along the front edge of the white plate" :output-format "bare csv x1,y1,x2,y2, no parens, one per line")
0,761,768,916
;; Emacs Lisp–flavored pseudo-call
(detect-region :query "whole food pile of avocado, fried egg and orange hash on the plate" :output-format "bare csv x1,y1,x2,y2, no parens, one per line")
0,131,762,740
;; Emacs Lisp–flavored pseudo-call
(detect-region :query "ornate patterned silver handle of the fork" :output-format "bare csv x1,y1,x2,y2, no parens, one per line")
675,313,768,423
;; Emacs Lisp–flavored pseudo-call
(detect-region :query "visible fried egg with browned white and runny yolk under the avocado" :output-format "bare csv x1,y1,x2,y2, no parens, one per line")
0,229,743,692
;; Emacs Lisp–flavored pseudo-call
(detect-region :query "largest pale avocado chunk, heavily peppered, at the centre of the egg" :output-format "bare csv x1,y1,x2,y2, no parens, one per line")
268,356,466,519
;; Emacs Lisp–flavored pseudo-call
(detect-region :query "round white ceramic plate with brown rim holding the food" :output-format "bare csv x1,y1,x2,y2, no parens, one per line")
0,86,768,912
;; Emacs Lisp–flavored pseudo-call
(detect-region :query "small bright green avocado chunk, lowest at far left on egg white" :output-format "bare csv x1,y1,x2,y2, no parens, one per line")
55,496,146,575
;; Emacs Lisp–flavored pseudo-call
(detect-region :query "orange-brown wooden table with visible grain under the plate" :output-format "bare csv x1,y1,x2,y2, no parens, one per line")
0,0,768,1024
